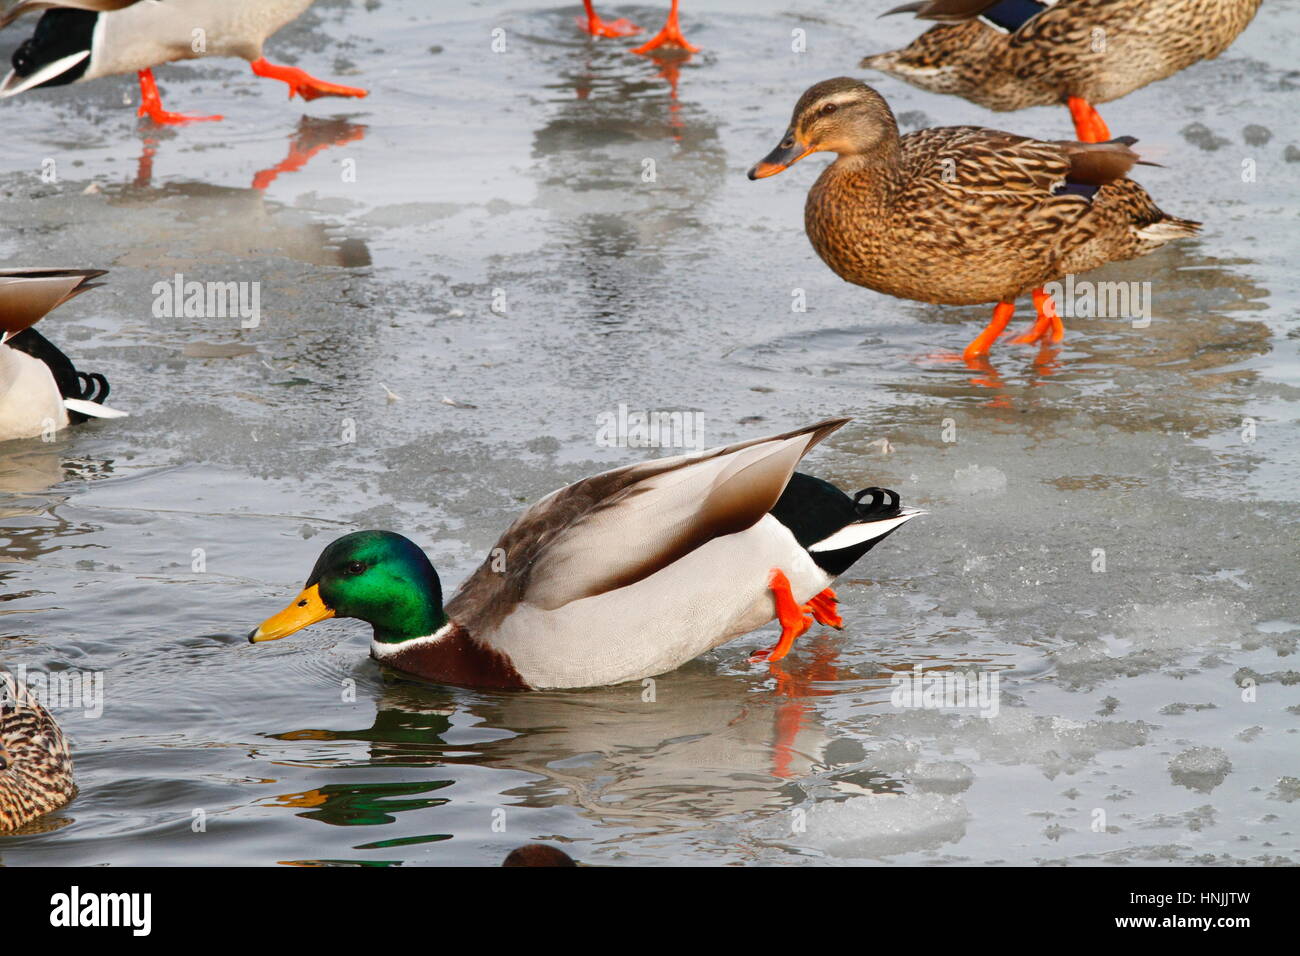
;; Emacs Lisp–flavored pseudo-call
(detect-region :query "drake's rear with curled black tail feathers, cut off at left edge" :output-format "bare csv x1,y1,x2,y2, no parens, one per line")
0,269,126,441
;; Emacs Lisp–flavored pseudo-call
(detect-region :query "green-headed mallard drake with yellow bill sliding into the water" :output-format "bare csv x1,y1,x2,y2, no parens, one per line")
248,419,920,689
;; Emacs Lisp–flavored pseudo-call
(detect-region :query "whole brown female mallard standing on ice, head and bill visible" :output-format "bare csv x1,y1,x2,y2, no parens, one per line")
749,77,1200,363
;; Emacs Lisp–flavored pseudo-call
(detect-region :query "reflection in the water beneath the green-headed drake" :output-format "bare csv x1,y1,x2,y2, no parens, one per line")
266,636,863,827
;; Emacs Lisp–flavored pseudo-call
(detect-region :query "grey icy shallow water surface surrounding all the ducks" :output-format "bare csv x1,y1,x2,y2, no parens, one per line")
0,0,1300,865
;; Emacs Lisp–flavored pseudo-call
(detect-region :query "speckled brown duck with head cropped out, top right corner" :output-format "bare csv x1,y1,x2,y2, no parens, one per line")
861,0,1260,143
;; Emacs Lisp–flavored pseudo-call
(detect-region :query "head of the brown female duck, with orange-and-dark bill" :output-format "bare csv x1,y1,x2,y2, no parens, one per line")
749,77,898,179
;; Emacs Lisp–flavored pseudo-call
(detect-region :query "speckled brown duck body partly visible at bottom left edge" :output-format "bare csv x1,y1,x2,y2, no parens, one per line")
0,674,77,832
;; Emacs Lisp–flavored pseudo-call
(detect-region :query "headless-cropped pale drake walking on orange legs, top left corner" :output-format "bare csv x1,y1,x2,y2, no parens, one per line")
0,0,367,124
